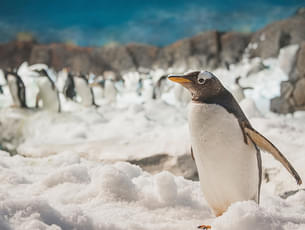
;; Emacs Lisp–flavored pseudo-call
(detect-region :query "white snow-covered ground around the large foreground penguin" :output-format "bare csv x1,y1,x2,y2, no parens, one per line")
0,56,305,230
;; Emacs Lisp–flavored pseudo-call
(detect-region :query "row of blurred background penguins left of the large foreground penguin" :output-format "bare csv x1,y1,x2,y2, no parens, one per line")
0,68,171,112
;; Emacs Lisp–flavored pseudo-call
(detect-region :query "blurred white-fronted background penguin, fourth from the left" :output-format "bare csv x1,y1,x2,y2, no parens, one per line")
74,74,97,106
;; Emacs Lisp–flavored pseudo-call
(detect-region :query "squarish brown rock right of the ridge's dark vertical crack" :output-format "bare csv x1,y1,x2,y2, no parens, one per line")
220,32,251,64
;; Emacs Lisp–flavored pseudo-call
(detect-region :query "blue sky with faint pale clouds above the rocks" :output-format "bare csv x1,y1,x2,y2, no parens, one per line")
0,0,305,46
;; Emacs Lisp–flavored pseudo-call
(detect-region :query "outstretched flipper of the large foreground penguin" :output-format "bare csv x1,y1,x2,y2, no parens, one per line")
244,127,302,185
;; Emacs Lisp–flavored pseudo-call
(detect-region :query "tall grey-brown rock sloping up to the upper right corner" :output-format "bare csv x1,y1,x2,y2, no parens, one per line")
249,8,305,58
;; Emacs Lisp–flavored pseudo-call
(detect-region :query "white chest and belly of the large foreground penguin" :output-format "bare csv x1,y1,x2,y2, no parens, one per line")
189,102,259,215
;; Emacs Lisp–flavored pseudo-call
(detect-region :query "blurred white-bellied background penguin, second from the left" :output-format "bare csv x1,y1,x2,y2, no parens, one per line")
35,69,61,112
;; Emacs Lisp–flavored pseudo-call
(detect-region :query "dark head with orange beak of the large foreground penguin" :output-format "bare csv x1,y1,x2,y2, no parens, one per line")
168,71,226,102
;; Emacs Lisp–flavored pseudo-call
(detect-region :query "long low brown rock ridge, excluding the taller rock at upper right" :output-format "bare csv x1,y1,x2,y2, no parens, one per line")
0,31,250,74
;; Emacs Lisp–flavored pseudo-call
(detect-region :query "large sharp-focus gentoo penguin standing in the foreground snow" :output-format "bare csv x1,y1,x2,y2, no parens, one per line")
168,71,302,228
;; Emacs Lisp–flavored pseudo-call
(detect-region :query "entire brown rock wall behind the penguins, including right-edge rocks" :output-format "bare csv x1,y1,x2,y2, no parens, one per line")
0,8,305,113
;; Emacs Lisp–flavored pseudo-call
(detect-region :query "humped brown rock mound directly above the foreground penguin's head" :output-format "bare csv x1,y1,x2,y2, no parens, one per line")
155,31,251,71
